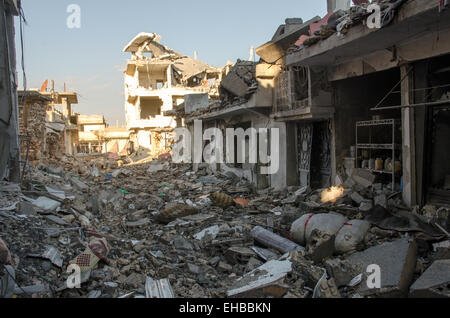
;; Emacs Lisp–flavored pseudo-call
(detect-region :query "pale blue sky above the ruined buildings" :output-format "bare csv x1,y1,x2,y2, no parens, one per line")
16,0,326,125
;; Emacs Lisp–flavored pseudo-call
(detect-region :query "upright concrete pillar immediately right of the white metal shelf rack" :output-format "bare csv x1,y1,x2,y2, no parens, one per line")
400,65,416,207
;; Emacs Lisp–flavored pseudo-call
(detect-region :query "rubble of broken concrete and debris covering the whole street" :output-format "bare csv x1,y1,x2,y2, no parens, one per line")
0,156,450,298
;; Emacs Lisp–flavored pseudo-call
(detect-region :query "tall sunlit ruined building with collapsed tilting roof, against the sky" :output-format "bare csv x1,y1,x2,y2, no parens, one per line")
124,33,222,156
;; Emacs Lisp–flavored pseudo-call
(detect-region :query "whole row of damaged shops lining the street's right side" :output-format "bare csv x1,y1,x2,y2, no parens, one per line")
184,0,450,206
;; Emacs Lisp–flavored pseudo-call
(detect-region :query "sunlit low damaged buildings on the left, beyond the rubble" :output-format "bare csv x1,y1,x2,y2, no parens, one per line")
18,81,132,161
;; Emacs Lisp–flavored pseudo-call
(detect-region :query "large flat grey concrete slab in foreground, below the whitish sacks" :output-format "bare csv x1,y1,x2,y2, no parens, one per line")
347,238,417,298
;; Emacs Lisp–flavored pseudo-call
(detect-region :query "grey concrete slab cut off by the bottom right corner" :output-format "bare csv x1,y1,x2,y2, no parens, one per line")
409,260,450,298
